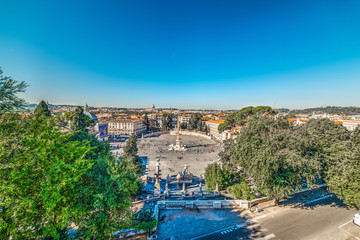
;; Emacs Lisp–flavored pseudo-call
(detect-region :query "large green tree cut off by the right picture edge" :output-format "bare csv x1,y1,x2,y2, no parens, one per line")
301,119,360,208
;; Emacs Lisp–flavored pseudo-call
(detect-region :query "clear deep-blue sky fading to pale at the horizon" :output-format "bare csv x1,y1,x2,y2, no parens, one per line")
0,0,360,109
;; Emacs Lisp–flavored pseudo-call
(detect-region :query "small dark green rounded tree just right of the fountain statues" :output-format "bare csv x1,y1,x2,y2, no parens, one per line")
205,163,233,190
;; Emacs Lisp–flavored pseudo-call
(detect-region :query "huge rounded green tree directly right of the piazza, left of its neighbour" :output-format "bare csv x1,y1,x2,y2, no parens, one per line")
220,117,321,200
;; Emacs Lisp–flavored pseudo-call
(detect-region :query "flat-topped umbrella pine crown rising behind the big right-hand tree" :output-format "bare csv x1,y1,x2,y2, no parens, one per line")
218,106,277,133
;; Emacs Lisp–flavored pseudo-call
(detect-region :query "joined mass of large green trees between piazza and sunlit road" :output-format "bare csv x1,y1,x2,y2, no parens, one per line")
219,116,360,208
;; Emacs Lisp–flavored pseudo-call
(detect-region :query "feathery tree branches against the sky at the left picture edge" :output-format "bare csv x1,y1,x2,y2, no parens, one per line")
0,68,28,114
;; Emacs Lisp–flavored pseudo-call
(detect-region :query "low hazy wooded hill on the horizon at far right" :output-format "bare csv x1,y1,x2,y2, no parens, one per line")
288,106,360,115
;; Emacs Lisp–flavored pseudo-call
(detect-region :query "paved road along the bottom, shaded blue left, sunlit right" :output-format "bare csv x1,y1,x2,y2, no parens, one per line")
158,190,360,240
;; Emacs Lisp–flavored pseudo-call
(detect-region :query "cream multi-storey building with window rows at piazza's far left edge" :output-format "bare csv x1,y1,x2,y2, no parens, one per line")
108,119,146,136
